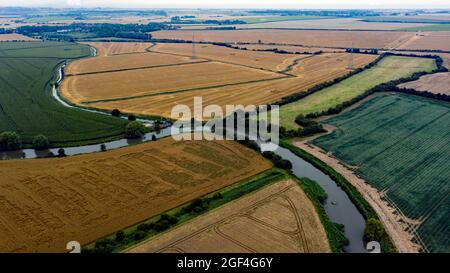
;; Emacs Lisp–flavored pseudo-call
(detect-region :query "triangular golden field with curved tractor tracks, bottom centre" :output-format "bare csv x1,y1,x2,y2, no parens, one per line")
128,180,330,253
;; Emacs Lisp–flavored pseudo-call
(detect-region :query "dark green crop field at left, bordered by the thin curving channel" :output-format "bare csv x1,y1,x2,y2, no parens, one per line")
0,42,125,145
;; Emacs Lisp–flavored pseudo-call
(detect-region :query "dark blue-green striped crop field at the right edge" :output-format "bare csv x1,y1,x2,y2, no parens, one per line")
313,94,450,252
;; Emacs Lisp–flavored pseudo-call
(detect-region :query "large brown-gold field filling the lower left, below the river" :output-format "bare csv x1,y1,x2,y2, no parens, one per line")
0,138,272,252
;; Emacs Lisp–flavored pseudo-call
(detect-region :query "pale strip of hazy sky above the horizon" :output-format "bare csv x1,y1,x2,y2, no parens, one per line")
0,0,450,9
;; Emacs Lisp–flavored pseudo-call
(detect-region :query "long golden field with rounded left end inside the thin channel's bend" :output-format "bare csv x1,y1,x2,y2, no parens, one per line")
61,62,284,103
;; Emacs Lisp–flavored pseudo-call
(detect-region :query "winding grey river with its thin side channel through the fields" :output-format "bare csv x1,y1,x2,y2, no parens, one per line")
0,47,366,253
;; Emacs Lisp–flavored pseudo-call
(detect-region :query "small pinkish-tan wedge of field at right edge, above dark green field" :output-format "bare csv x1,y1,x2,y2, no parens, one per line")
399,73,450,95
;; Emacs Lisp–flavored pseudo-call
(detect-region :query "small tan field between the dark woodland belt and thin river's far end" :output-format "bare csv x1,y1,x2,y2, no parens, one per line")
82,42,152,56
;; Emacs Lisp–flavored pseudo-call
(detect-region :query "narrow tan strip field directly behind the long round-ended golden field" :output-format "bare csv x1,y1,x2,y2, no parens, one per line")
151,43,309,71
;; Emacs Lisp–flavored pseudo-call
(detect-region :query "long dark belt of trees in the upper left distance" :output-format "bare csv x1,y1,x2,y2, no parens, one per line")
17,23,172,40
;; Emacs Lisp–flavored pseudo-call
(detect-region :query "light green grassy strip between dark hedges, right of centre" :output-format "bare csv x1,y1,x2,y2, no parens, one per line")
280,56,436,129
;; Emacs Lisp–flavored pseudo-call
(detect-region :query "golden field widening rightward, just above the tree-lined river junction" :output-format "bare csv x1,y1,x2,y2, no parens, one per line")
90,53,377,117
